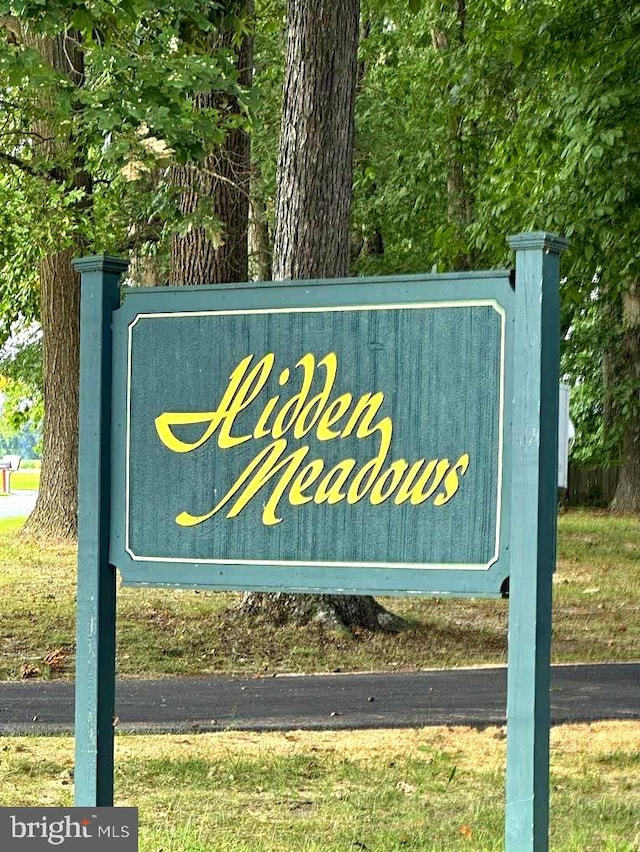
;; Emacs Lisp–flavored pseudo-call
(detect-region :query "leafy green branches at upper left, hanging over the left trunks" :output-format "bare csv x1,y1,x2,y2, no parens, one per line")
0,0,252,272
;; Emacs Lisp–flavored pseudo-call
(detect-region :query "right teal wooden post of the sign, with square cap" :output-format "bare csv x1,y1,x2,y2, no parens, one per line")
505,233,567,852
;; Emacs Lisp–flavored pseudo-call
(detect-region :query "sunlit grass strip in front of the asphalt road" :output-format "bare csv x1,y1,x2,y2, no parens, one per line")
0,722,640,852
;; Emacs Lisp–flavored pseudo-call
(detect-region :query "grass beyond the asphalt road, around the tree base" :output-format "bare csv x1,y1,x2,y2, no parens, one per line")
0,511,640,680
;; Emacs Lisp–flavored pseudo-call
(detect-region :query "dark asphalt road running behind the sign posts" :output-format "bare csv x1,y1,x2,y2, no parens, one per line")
0,663,640,734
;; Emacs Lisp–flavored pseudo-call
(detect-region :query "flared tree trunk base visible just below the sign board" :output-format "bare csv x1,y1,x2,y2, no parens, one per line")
240,592,405,633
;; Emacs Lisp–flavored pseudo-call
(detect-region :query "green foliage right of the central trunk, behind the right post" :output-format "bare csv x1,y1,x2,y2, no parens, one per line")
353,0,640,463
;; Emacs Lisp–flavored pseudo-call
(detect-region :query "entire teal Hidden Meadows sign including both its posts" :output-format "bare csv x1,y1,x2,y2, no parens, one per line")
75,233,566,852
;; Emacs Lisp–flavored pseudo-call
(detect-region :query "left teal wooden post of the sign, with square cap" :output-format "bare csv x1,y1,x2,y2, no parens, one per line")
74,255,128,807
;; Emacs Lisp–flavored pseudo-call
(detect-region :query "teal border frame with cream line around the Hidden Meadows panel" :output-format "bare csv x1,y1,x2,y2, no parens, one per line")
110,270,515,597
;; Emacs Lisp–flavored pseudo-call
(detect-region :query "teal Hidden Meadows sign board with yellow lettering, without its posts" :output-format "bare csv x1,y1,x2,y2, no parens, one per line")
110,272,514,594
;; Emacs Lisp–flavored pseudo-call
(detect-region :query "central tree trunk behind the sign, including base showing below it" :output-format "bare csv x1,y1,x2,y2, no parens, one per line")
242,0,402,631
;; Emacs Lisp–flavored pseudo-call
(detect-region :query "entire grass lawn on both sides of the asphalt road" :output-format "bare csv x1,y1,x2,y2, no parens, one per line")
0,511,640,852
